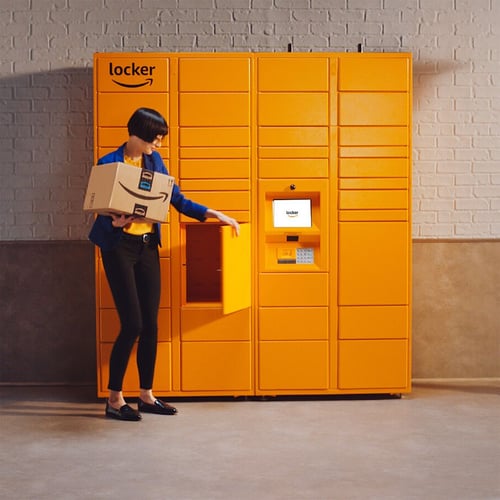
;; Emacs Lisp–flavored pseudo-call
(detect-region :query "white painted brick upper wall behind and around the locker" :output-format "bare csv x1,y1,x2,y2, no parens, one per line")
0,0,500,240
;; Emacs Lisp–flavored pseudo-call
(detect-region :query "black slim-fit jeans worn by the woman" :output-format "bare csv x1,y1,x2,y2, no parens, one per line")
101,235,161,391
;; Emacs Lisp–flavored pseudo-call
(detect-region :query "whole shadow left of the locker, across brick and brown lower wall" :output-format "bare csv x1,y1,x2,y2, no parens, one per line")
0,68,96,384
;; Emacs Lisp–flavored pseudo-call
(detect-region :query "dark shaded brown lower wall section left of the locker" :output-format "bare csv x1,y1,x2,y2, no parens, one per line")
0,241,96,385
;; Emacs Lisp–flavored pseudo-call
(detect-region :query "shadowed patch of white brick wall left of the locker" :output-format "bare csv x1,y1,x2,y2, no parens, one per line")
0,68,93,240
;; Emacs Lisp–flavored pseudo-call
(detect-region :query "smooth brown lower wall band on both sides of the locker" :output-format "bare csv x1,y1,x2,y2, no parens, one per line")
0,240,500,385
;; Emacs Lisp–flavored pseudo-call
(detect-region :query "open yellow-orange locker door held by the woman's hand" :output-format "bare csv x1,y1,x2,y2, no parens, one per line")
221,224,252,314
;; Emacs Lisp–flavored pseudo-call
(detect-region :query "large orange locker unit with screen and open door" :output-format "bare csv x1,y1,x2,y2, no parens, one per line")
94,53,412,396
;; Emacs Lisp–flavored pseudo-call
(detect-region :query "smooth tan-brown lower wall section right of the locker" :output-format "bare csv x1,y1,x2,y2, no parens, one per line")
413,240,500,378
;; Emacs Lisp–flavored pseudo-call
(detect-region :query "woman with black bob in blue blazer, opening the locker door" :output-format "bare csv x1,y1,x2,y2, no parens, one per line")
89,108,239,421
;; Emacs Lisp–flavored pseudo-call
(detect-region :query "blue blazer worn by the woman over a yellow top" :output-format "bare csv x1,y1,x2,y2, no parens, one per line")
89,144,207,251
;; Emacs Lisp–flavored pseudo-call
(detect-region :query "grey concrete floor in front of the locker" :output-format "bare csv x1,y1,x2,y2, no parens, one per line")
0,380,500,500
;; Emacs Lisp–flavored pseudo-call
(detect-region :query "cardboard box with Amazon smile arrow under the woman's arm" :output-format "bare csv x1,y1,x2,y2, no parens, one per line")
83,162,174,222
